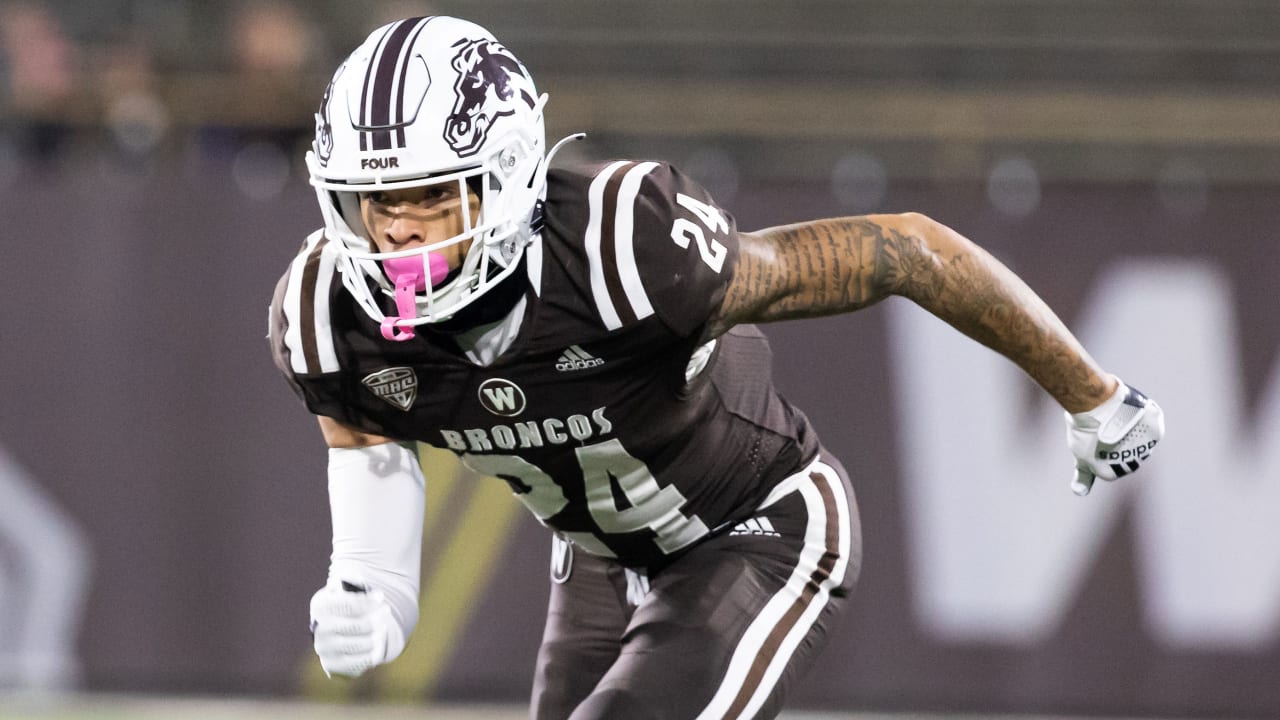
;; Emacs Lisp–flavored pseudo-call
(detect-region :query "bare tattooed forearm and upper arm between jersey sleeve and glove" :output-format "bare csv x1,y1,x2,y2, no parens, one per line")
709,215,1110,411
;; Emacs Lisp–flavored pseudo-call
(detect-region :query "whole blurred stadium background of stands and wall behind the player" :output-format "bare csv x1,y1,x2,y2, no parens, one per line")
0,0,1280,719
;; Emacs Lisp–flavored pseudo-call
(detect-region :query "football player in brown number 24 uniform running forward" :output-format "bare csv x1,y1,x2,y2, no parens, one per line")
270,17,1164,720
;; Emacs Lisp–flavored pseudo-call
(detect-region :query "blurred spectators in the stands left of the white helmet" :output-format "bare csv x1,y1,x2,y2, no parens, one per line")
0,0,430,167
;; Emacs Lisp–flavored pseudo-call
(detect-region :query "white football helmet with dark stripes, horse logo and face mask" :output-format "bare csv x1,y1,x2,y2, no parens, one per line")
306,17,565,340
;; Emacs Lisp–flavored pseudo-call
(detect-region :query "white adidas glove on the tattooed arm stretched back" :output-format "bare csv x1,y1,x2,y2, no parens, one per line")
1066,382,1165,496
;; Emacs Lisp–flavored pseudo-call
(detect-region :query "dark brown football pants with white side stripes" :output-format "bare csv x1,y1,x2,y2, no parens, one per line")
530,456,861,720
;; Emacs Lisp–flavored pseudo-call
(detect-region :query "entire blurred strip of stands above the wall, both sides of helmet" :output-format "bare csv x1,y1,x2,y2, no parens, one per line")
0,0,1280,197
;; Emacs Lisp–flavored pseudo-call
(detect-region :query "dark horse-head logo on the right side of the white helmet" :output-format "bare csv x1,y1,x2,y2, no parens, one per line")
444,40,534,158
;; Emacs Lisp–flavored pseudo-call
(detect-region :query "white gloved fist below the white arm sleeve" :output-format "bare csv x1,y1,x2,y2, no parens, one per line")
311,579,404,678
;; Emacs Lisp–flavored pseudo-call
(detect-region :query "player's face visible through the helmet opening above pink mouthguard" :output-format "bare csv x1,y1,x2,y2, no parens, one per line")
360,182,480,270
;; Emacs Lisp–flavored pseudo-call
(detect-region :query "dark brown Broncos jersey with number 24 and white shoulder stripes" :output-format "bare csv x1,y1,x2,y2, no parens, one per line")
270,161,818,566
